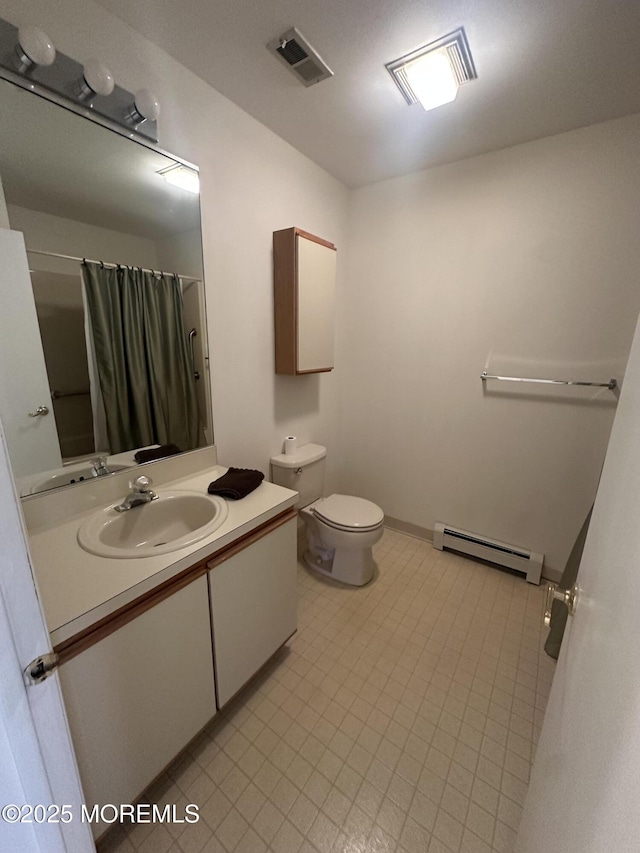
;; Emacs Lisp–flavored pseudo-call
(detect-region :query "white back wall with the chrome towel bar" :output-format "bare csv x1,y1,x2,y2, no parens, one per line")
338,116,640,570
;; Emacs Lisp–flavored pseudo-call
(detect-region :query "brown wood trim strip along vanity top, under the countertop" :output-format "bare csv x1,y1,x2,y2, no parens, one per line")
53,507,297,664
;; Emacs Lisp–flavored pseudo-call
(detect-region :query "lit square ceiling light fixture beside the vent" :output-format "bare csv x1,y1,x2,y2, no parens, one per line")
385,27,478,110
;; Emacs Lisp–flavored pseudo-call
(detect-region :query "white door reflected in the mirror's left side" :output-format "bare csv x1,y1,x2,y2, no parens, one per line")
0,228,62,478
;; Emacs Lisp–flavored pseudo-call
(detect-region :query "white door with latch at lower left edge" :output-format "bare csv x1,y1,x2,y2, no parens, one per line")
0,424,95,853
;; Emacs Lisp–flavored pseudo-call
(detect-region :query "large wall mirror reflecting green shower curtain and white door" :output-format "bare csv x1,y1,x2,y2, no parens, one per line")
0,81,213,496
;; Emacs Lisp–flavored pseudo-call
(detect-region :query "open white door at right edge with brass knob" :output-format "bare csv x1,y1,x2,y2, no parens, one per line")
515,308,640,853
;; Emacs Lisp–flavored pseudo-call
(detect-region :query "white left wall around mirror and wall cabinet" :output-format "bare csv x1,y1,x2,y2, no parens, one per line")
2,0,347,490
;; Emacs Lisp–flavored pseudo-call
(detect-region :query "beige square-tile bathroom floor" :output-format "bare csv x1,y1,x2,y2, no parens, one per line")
100,530,554,853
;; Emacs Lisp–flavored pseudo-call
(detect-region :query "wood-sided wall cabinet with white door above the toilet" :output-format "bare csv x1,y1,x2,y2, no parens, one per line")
273,228,336,375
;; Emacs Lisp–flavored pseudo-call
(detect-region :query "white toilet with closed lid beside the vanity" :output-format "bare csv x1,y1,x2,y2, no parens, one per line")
271,444,384,586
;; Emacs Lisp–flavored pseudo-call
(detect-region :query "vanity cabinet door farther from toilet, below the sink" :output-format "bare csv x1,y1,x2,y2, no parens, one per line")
60,575,216,836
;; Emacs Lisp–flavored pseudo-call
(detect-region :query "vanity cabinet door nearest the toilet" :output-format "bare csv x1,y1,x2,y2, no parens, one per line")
209,518,297,708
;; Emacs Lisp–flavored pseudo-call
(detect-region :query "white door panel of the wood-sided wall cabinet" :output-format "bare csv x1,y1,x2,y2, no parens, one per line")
296,240,336,372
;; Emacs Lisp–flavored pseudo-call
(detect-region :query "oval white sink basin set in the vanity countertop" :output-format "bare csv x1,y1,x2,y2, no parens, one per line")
78,491,229,560
